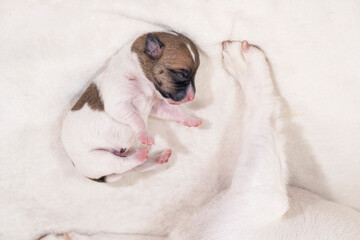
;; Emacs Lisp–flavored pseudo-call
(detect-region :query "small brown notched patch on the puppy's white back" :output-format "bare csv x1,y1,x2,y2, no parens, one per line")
71,83,104,111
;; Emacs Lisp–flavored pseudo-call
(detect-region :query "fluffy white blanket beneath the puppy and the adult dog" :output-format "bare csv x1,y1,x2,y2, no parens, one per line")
0,0,360,239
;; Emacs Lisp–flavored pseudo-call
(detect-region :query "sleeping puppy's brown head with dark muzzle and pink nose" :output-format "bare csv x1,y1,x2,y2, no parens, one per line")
131,32,200,104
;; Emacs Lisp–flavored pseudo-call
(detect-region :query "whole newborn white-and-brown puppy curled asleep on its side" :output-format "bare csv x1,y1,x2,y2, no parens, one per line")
62,32,201,182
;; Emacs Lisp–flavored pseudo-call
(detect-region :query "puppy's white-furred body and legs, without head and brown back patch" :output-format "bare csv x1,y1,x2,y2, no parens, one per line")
62,43,200,182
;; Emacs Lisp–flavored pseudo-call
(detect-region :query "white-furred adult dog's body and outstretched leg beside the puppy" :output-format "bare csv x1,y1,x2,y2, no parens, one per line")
40,42,360,240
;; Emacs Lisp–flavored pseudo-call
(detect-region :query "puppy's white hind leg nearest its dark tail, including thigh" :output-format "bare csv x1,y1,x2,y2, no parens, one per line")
76,147,148,179
